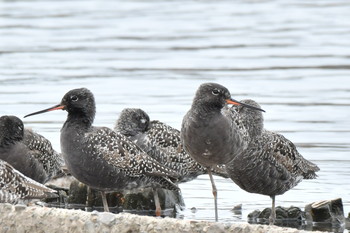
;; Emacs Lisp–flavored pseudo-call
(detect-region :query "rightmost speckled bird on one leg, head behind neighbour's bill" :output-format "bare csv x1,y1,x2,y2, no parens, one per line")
226,99,320,224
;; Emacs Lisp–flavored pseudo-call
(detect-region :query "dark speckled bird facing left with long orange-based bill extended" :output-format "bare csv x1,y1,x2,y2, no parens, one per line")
25,88,178,213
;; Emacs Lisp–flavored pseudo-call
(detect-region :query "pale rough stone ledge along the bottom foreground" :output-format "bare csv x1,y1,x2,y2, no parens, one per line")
0,204,326,233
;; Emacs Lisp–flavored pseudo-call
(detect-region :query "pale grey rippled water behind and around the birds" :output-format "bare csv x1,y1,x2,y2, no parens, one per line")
0,0,350,231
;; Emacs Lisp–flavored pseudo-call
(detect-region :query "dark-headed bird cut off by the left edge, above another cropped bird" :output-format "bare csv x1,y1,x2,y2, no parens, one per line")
0,116,64,184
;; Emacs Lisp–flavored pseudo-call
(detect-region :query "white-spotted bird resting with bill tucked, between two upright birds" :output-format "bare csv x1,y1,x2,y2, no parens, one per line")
114,108,228,183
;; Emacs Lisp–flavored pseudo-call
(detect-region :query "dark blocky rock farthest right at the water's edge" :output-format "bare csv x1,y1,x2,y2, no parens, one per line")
305,198,345,225
